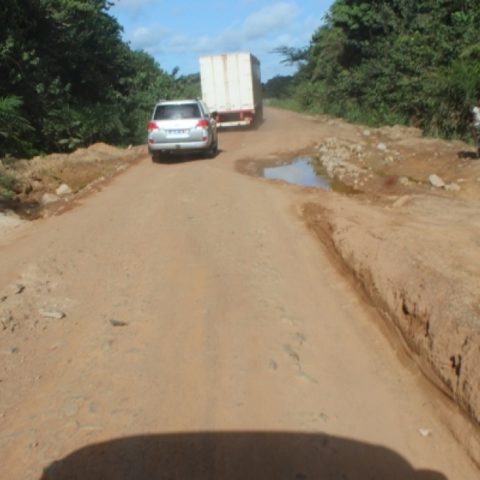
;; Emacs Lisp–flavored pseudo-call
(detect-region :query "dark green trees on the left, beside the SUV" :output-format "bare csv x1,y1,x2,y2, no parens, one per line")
0,0,198,156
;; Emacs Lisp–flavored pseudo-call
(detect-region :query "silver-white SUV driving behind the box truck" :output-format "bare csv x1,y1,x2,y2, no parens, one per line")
147,100,218,162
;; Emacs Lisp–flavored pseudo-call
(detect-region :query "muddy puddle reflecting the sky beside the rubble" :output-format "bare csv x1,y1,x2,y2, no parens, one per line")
263,157,332,190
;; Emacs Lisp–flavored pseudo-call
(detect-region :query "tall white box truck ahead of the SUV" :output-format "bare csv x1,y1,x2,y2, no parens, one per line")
199,52,263,127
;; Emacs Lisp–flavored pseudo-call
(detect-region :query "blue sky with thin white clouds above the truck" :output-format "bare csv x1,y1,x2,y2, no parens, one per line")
109,0,333,81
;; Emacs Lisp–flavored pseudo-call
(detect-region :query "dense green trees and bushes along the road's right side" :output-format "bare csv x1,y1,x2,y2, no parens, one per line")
265,0,480,138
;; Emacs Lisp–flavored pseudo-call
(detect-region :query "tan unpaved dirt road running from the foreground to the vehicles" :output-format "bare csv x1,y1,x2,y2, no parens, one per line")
0,110,479,480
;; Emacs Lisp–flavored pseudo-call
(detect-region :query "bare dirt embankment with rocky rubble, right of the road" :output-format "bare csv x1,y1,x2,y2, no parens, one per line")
296,123,480,461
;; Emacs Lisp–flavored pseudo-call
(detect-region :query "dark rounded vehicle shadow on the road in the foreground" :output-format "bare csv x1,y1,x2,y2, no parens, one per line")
41,432,446,480
